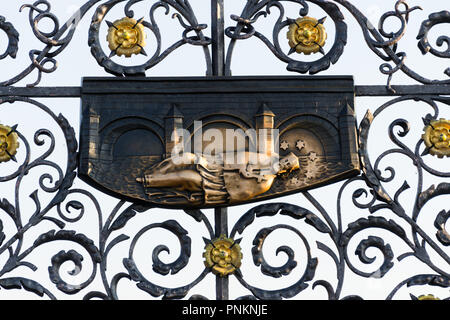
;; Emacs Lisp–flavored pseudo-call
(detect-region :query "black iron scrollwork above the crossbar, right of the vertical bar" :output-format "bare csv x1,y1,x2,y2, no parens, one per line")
229,0,450,87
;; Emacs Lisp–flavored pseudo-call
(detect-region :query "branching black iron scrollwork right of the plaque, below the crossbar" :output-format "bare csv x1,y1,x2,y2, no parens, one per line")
350,96,450,298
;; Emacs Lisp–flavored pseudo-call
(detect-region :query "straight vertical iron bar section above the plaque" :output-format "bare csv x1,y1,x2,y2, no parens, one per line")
211,0,225,76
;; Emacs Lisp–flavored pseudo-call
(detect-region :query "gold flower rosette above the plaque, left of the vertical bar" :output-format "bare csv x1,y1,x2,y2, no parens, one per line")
106,17,146,58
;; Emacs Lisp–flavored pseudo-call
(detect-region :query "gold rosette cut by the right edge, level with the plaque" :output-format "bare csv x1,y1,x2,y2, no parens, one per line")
422,119,450,158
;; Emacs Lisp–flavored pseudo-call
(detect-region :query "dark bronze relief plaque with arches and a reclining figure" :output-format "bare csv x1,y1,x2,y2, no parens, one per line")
78,76,360,208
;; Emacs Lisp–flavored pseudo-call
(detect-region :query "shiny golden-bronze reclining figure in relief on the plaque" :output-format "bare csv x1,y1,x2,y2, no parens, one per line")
137,152,300,205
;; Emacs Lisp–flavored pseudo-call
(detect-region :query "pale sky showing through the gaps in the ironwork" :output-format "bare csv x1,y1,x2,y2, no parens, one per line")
0,0,450,299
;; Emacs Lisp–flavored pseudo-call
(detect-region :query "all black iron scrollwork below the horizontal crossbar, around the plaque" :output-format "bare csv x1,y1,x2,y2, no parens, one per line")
0,100,450,299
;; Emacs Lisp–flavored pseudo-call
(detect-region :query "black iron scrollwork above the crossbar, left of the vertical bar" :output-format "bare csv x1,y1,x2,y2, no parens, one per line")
0,0,211,87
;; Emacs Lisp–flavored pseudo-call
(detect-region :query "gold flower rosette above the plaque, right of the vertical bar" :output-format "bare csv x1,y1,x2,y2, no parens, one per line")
287,17,327,55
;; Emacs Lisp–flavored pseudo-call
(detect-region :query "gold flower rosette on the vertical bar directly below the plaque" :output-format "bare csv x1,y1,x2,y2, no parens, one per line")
203,234,242,277
